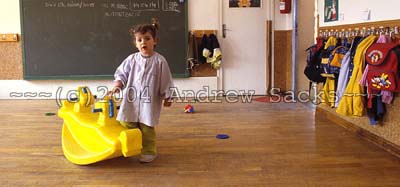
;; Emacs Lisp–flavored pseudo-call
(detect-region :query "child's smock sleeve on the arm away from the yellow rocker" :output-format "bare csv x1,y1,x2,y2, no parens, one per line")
160,61,174,99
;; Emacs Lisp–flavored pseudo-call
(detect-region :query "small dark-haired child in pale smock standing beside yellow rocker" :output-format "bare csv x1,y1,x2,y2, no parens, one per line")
110,24,173,162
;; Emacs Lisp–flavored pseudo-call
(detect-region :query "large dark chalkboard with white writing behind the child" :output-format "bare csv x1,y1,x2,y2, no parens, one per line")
20,0,189,79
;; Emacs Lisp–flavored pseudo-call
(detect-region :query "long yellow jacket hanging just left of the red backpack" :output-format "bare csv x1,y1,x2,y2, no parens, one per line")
336,35,377,116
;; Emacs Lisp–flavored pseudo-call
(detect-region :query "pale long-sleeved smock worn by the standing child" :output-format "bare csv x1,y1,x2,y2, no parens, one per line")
114,52,174,127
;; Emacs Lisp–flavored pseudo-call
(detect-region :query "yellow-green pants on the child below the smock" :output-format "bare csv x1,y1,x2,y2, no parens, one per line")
120,121,157,155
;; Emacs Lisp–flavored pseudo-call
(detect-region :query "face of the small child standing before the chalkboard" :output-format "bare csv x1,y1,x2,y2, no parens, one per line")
135,32,157,56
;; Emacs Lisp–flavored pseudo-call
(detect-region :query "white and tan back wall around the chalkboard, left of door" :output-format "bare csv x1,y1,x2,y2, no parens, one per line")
0,0,220,99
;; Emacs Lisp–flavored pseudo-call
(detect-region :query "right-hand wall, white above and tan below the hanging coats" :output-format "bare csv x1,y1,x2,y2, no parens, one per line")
318,0,400,148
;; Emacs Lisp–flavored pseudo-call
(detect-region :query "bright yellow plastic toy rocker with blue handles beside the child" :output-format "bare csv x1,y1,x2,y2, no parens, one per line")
58,87,142,165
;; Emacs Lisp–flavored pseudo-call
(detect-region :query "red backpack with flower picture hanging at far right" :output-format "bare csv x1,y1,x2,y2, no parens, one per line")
365,43,400,106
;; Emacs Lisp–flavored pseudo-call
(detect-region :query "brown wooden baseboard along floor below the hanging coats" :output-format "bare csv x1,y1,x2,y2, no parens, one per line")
315,107,400,157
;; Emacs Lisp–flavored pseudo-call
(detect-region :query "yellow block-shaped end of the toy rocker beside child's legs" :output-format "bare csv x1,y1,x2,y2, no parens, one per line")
119,129,142,157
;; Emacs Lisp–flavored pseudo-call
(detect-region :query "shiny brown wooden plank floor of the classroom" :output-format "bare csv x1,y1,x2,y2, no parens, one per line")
0,100,400,187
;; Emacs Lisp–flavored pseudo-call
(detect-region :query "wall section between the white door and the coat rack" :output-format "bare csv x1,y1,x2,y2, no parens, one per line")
274,1,315,95
